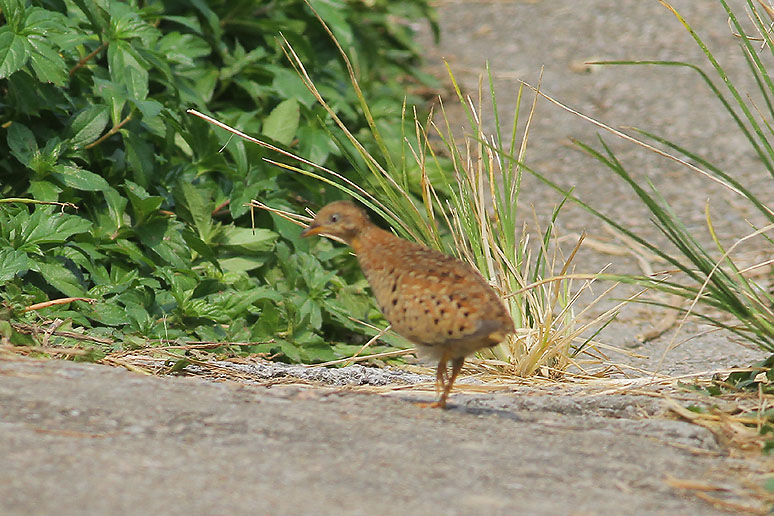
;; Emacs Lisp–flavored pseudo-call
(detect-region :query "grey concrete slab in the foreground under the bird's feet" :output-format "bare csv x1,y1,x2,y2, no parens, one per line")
0,360,764,516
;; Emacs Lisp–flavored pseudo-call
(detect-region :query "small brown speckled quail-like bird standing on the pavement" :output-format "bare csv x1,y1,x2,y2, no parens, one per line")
301,201,514,408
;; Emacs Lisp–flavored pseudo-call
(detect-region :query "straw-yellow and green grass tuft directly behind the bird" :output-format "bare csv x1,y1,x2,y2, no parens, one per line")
196,9,615,376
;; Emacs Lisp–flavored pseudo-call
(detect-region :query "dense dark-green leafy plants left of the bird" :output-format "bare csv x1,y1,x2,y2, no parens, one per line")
0,0,432,362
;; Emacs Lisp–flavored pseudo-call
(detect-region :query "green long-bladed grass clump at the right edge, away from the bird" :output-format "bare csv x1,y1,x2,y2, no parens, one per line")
513,0,774,388
